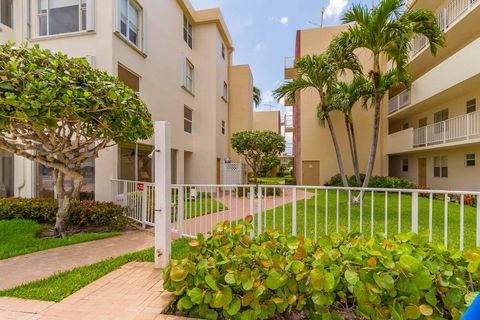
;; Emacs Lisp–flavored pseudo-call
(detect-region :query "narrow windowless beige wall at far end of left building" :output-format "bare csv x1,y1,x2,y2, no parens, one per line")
228,65,253,162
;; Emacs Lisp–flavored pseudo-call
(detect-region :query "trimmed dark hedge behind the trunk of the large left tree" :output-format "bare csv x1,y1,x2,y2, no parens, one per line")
0,198,127,230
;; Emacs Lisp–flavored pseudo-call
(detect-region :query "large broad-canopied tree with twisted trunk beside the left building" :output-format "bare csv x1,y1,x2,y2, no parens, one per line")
0,43,153,236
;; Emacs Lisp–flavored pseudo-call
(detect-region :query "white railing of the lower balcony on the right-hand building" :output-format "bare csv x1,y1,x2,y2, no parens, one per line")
413,111,480,148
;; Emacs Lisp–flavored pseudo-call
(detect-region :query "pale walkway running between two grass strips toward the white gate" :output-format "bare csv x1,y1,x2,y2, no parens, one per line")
0,232,154,292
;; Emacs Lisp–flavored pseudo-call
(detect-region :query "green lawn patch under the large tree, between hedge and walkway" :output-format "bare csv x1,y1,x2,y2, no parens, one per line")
0,220,119,260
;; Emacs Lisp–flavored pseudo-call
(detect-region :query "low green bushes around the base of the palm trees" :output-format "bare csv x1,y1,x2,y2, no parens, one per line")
325,174,417,189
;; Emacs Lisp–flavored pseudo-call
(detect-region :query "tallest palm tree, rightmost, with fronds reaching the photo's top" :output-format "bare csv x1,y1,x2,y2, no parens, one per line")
329,0,445,187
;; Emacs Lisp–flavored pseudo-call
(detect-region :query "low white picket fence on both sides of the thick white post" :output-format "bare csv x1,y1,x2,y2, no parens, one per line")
112,180,480,250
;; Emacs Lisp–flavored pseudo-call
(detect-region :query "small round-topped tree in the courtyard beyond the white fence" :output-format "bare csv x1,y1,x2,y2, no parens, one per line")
231,130,285,184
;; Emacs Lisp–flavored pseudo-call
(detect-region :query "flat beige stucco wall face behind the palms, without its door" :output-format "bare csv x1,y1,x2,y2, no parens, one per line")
295,26,387,184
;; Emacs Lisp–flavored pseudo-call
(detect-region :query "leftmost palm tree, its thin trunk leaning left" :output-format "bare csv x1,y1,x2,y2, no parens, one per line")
274,53,360,187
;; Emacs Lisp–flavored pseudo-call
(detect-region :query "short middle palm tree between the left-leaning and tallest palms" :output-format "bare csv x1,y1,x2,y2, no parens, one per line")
328,76,373,186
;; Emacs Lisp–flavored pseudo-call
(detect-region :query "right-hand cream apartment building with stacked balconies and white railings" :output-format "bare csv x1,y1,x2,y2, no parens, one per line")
384,0,480,190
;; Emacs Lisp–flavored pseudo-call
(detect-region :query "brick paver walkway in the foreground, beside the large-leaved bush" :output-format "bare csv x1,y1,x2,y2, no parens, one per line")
0,262,189,320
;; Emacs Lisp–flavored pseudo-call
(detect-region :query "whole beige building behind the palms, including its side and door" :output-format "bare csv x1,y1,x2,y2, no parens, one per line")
285,26,388,185
